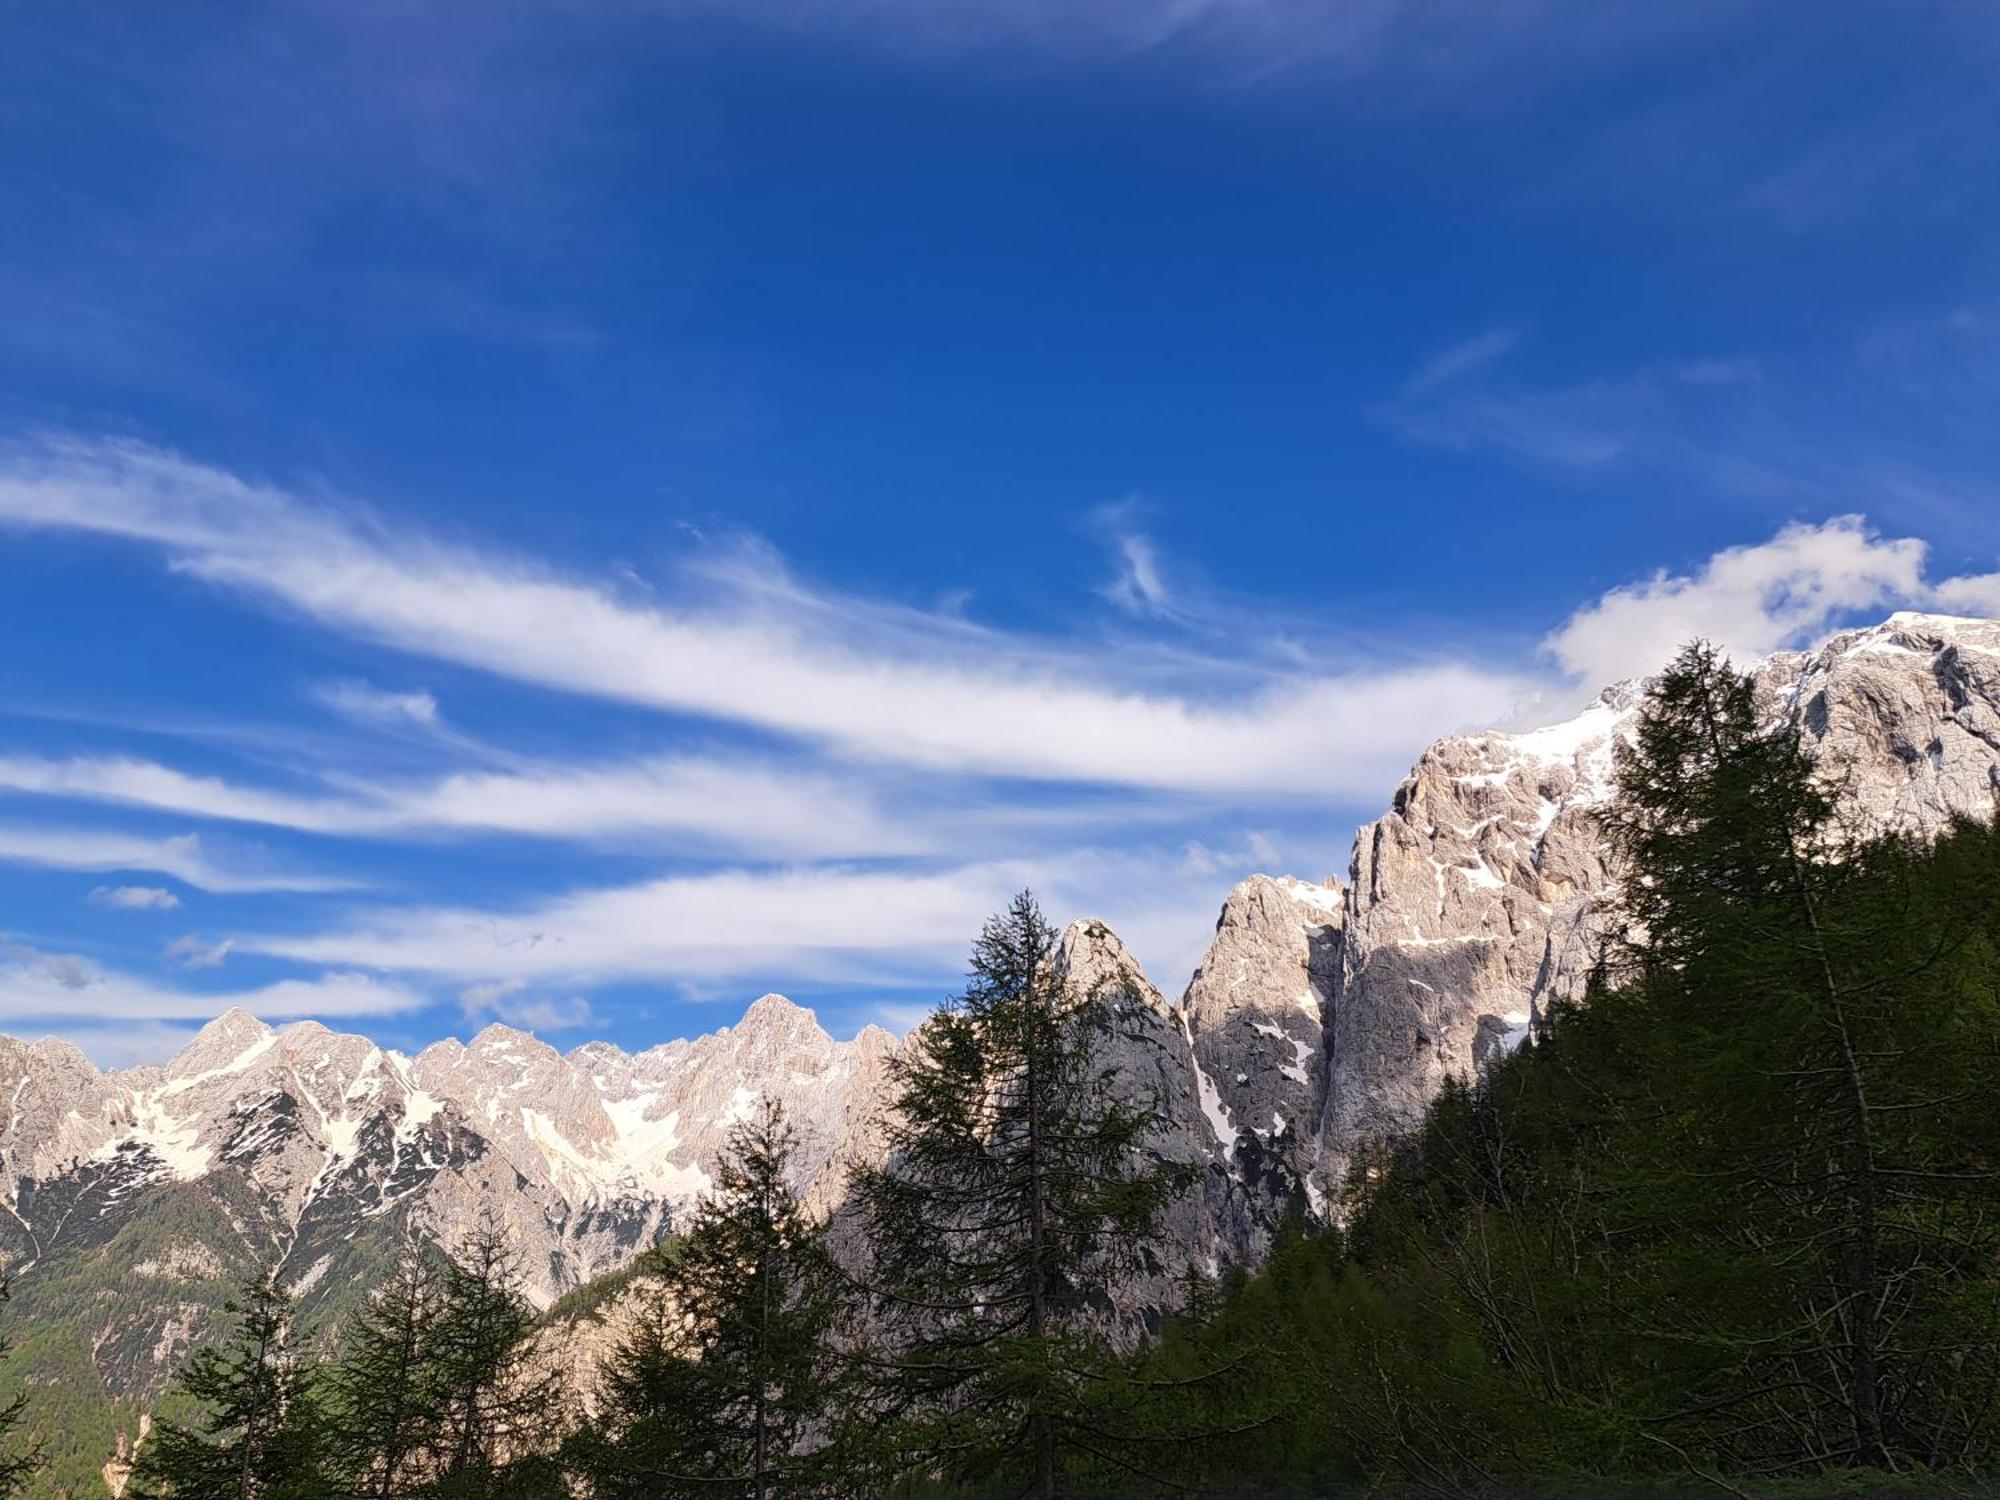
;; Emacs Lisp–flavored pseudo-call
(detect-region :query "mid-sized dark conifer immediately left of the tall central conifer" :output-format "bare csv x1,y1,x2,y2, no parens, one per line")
586,1102,844,1500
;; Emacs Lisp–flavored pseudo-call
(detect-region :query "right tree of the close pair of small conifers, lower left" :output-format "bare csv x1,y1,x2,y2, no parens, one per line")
428,1220,564,1500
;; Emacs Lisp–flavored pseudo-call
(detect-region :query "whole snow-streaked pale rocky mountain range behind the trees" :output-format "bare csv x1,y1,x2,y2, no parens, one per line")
0,614,2000,1496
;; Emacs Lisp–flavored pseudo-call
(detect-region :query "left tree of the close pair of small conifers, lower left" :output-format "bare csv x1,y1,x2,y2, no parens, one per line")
328,1240,444,1500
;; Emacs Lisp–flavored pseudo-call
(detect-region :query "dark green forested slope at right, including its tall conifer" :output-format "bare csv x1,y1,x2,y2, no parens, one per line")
1104,648,2000,1494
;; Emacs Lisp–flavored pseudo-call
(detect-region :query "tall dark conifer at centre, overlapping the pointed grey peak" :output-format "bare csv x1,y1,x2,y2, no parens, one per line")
856,892,1178,1496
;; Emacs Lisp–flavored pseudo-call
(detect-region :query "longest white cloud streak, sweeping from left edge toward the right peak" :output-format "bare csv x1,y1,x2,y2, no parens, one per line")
0,442,1532,796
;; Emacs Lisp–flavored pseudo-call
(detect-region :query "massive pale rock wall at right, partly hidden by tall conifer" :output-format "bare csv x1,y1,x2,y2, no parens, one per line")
1318,614,2000,1182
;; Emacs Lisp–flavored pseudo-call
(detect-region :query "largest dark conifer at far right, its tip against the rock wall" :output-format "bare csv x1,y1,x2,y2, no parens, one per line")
1606,646,1996,1466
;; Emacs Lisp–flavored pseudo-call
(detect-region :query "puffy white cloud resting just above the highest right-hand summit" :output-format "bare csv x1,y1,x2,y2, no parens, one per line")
1544,516,1928,684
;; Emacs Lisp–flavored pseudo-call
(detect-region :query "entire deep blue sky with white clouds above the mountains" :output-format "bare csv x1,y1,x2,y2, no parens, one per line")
0,0,2000,1062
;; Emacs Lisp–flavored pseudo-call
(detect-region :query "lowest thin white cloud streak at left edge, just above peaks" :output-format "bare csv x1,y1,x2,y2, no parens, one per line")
0,944,428,1026
